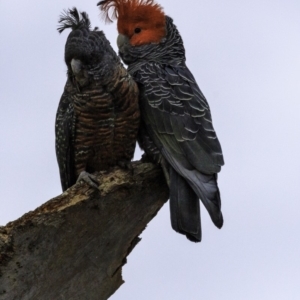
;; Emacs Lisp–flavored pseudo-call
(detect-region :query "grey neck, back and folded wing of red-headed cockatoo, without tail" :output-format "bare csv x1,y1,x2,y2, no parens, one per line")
120,17,224,170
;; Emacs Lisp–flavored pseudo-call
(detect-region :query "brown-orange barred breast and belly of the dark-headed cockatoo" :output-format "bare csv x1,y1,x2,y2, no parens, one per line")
73,68,139,177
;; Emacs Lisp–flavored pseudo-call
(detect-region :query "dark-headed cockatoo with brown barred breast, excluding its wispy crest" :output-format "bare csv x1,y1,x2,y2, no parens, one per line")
56,8,140,190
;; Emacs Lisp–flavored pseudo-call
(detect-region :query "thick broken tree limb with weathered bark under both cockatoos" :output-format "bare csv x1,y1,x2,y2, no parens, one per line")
0,162,168,300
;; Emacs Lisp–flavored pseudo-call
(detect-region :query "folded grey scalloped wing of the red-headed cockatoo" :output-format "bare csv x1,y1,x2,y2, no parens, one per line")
134,63,224,174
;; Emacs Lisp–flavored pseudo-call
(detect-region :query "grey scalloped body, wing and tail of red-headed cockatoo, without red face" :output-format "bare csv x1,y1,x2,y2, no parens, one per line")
119,16,224,242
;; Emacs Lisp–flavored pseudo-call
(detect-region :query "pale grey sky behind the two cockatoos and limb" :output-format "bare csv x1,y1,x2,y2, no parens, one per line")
0,0,300,300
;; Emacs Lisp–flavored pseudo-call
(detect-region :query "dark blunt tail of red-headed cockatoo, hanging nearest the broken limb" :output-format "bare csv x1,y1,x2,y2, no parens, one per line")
170,167,201,242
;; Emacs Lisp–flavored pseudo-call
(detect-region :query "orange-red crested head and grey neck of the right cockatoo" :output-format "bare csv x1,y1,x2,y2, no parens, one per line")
97,0,185,67
